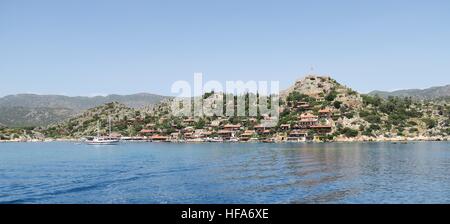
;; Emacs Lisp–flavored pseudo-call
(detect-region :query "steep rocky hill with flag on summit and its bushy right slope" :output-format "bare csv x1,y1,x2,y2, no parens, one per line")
282,76,450,139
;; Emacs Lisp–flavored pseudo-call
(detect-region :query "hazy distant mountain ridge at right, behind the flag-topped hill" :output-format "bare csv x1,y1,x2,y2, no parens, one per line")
369,85,450,100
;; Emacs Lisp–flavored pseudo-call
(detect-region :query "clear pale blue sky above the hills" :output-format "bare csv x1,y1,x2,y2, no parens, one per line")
0,0,450,96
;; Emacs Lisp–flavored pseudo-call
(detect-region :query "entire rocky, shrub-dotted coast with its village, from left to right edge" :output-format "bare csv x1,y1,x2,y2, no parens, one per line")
0,75,450,143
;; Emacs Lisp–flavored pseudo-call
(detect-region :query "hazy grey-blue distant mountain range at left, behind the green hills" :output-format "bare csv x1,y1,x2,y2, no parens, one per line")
0,93,170,127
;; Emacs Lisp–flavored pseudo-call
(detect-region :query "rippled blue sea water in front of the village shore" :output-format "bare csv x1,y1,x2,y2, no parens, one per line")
0,142,450,203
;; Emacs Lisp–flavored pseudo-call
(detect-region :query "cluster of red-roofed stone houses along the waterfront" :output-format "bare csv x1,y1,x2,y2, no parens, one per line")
126,109,333,143
